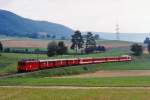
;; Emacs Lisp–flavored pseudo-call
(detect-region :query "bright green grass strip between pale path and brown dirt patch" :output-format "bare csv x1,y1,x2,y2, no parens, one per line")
0,76,150,87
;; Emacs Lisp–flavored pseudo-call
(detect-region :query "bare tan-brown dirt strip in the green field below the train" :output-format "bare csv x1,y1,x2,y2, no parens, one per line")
56,70,150,78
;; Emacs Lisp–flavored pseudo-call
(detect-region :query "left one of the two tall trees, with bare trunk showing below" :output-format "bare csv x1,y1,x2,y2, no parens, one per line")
71,31,84,53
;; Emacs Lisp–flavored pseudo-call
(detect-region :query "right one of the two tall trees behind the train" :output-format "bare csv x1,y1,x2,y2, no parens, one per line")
86,32,96,48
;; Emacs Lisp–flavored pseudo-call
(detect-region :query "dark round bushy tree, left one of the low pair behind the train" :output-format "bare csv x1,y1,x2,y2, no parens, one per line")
47,41,58,57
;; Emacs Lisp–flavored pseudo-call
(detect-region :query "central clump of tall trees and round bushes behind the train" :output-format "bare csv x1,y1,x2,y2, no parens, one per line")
47,30,103,57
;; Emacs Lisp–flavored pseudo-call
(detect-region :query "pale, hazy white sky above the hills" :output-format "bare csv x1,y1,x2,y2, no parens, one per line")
0,0,150,33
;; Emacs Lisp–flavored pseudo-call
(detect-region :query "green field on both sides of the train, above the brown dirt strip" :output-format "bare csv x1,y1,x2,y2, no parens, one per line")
0,48,150,77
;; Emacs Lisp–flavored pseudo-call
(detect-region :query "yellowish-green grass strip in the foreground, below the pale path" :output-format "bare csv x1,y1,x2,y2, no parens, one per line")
0,88,150,100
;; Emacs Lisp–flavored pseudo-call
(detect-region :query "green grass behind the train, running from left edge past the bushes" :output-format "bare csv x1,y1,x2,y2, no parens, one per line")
0,47,124,75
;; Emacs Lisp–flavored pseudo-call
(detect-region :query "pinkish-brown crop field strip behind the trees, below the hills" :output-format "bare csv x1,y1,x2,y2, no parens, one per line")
1,39,132,48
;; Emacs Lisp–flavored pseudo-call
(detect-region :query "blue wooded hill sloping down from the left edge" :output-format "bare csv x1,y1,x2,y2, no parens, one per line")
0,10,73,38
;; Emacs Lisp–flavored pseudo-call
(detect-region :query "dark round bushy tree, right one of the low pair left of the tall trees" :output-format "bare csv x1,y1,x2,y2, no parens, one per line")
57,41,68,55
